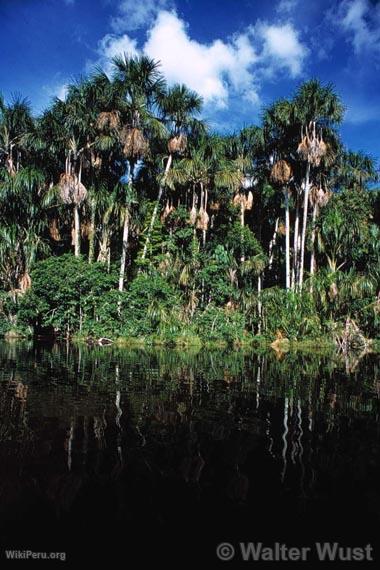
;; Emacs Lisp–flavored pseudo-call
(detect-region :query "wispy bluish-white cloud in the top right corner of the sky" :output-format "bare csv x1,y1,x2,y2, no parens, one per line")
337,0,380,54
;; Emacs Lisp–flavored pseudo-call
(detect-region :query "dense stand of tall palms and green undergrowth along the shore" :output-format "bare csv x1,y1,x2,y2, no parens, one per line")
0,55,380,344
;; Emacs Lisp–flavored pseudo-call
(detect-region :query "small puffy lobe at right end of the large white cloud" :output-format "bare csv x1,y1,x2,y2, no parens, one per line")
253,23,309,77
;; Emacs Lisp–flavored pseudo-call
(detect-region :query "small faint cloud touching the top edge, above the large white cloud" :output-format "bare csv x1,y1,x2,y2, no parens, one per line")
111,0,172,33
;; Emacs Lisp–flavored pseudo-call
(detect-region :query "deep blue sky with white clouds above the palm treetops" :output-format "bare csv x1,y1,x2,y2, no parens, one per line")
0,0,380,162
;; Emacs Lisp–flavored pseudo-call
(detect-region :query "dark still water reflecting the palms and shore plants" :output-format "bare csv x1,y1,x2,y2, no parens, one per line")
0,343,380,568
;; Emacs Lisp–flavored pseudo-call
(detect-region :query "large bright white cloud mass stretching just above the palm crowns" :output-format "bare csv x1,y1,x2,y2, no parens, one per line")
97,8,308,109
